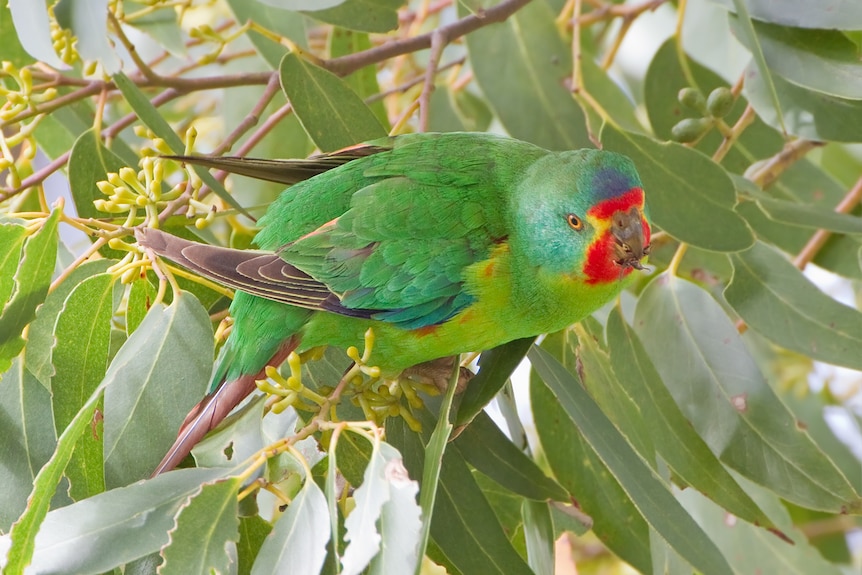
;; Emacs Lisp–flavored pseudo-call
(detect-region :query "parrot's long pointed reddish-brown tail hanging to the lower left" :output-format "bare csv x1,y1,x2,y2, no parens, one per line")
153,337,299,477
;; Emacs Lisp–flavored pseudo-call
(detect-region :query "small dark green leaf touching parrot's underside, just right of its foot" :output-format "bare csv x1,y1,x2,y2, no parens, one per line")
455,337,536,428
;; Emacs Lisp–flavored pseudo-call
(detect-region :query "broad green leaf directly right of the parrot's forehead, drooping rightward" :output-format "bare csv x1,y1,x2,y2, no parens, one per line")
602,126,754,252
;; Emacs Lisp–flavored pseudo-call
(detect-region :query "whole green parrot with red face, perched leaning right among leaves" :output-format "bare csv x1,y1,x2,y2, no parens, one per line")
137,133,650,473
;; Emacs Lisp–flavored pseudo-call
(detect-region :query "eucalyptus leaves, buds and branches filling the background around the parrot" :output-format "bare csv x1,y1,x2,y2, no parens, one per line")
0,0,862,575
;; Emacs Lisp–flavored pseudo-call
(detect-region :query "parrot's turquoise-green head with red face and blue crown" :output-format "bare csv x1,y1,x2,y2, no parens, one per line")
515,149,650,284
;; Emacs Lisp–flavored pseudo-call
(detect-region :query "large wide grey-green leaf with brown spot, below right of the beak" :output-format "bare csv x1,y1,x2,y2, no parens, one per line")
634,274,860,512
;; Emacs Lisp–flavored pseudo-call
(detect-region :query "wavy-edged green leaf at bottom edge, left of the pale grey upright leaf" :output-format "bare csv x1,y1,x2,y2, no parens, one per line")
159,477,242,575
